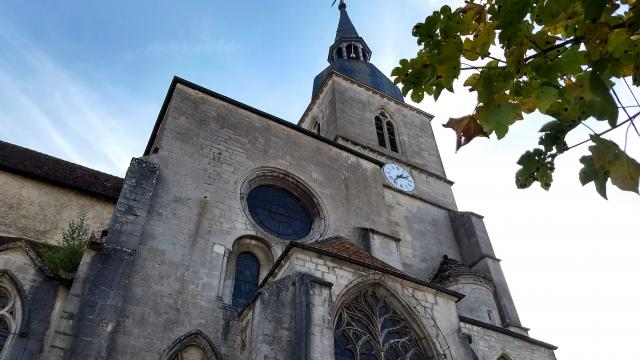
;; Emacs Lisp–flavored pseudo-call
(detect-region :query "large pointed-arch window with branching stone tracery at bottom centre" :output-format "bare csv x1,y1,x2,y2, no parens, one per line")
334,286,432,360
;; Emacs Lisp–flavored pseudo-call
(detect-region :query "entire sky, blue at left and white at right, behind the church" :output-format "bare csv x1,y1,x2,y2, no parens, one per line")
0,0,640,359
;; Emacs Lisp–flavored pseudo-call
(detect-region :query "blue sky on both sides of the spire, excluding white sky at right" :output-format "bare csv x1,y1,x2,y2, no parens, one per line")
0,0,424,175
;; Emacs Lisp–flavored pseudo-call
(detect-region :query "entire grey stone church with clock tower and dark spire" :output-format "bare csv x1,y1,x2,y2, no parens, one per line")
0,1,556,360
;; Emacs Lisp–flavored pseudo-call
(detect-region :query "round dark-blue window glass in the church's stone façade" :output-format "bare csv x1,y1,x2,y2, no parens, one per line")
247,185,312,240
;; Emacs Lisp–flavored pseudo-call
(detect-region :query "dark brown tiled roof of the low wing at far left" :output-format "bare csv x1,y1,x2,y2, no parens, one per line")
0,141,123,201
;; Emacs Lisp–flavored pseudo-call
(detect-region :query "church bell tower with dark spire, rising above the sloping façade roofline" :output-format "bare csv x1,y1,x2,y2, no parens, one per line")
298,1,455,207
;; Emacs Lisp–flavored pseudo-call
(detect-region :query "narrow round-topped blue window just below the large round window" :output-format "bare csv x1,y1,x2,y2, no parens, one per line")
231,252,260,308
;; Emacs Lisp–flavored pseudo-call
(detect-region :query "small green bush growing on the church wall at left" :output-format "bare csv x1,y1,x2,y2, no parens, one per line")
43,217,89,274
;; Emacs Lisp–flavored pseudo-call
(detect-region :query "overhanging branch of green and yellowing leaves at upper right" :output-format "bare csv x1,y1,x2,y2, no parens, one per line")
392,0,640,198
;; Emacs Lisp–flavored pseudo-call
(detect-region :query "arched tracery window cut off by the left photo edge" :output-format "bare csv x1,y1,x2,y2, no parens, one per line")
0,272,23,359
